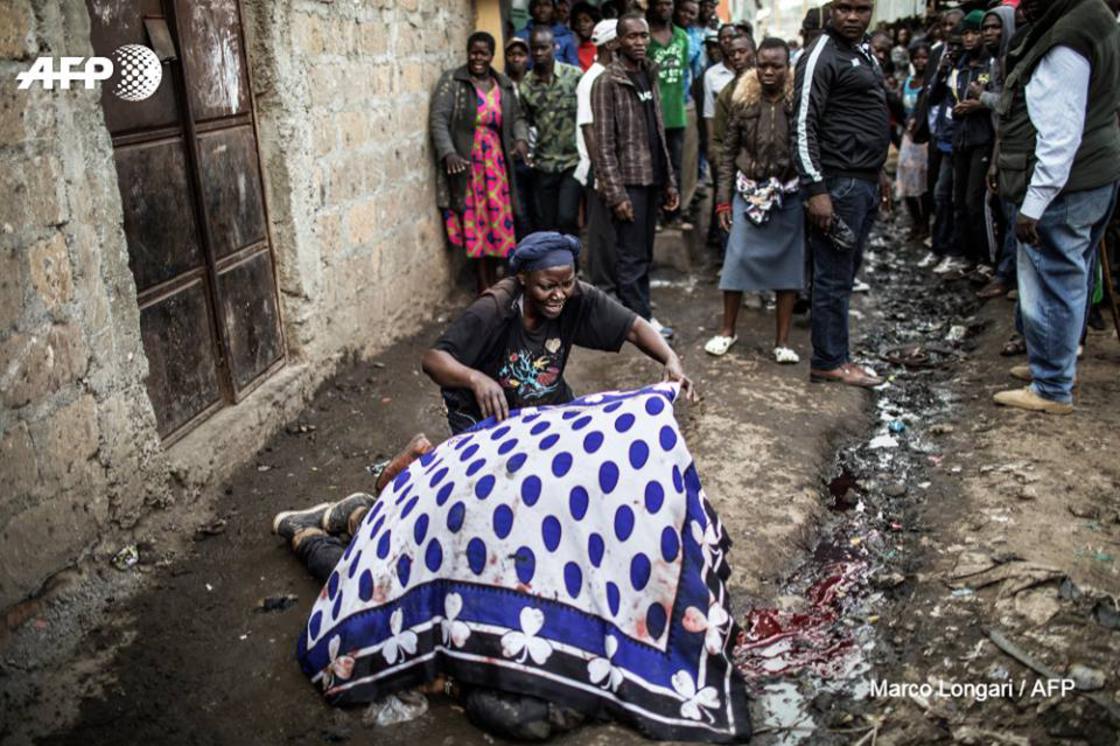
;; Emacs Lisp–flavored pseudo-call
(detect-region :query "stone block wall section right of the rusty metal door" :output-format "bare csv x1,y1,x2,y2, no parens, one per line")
243,0,473,360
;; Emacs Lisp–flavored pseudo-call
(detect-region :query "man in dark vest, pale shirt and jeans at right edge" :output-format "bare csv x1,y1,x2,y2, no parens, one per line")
990,0,1120,414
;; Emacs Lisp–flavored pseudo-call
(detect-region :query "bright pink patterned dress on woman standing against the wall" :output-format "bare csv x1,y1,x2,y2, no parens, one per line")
444,85,517,259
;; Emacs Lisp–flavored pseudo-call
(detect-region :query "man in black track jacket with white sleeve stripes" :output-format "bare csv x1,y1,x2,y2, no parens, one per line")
794,0,890,388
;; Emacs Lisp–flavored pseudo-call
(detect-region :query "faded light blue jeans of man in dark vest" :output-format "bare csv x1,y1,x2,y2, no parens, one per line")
1018,183,1120,402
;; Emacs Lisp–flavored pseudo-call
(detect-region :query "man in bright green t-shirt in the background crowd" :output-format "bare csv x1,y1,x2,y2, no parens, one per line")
645,0,689,223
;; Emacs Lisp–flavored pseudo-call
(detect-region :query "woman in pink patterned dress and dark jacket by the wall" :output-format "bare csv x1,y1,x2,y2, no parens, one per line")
430,31,528,292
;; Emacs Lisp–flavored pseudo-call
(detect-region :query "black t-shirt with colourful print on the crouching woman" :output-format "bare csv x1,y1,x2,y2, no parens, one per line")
435,278,635,421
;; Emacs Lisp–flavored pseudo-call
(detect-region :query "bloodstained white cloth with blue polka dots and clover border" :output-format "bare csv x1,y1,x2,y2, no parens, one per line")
298,383,750,742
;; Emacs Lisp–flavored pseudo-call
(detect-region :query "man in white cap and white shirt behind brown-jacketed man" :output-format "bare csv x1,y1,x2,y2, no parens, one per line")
576,18,618,295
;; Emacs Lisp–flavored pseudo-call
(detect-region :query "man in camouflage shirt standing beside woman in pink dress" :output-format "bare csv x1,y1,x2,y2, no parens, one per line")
521,26,582,235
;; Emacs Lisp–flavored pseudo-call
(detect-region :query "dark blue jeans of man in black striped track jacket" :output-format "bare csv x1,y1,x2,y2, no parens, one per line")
806,177,879,371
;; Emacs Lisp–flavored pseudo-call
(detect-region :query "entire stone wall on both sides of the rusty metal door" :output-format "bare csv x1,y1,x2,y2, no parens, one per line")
0,0,473,609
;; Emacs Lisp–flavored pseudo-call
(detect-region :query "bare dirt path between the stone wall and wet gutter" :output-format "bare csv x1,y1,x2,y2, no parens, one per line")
0,239,871,744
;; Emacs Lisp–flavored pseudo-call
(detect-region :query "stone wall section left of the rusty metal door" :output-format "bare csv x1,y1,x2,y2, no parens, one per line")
0,0,167,608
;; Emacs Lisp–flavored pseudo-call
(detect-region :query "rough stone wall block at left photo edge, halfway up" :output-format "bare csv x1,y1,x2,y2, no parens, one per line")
0,324,88,409
